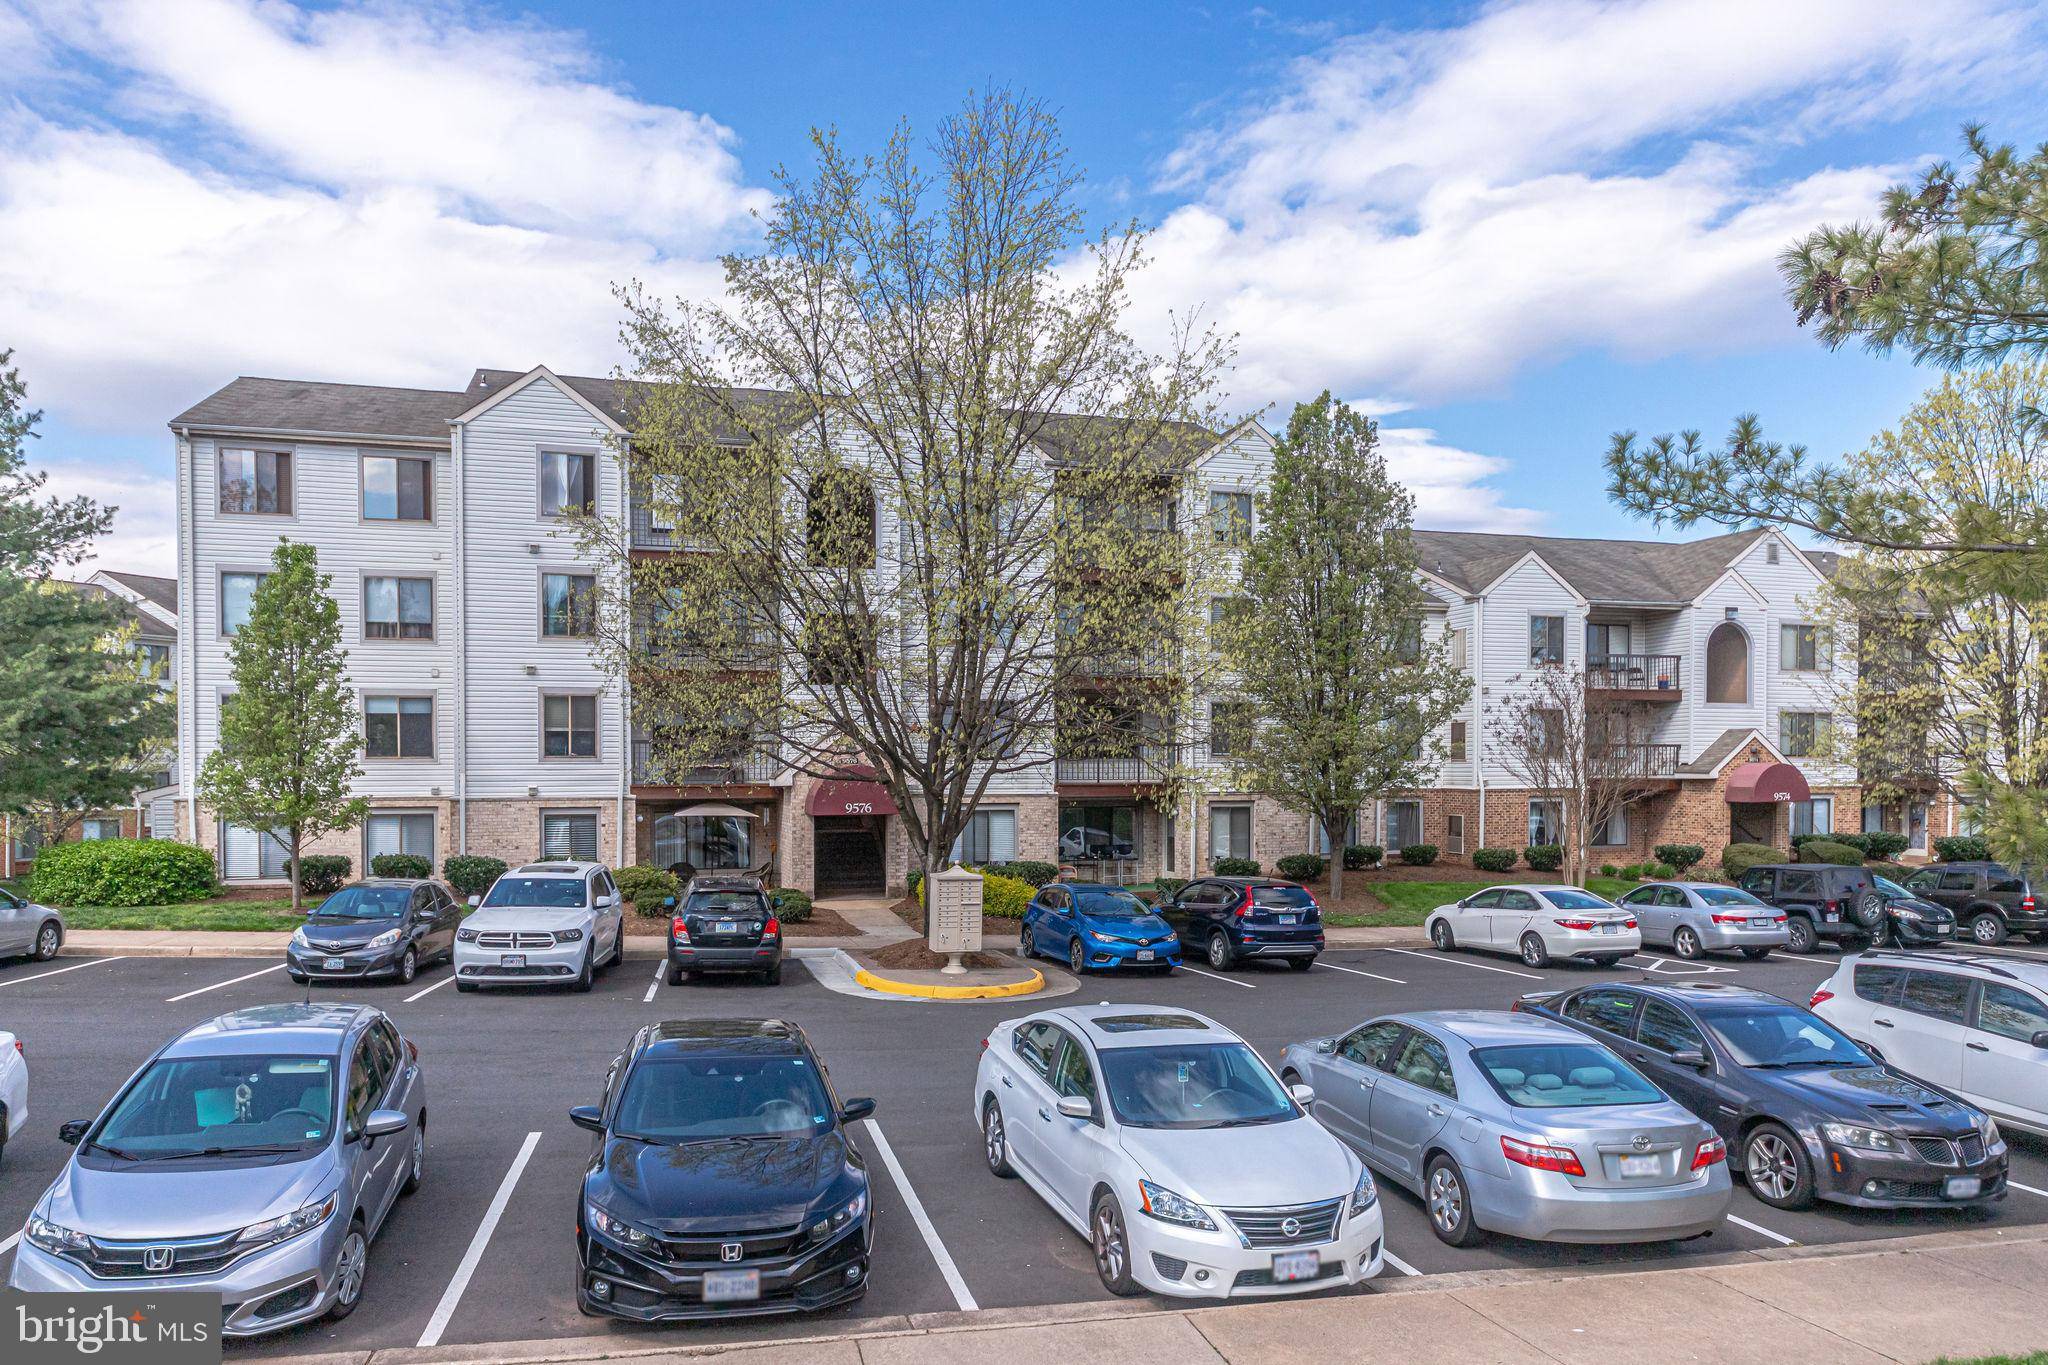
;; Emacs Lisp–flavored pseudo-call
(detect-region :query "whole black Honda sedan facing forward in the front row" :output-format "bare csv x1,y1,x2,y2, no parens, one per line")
569,1019,874,1322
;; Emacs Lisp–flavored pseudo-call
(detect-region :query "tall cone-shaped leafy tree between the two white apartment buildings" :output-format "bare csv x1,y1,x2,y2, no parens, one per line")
1219,391,1470,898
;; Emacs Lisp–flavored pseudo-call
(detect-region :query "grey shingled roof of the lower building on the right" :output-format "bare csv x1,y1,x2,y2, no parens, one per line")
1415,530,1765,606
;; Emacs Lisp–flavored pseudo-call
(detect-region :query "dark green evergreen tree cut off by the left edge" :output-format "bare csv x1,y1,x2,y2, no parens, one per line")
0,352,172,845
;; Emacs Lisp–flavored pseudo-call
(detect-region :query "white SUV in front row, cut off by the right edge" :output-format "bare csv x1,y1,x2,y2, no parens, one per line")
1810,952,2048,1136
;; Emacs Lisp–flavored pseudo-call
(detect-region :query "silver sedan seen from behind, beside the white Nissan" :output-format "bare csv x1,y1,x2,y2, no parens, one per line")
1280,1009,1733,1246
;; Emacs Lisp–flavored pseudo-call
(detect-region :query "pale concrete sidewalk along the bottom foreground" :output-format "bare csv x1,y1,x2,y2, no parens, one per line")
243,1230,2048,1365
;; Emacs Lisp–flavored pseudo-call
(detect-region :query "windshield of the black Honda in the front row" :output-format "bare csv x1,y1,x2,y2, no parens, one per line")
612,1054,831,1142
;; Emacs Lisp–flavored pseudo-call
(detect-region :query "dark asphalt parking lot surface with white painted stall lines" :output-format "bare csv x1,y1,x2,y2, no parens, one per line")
0,948,2048,1355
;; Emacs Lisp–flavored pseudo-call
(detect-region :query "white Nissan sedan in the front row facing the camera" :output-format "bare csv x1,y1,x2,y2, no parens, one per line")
975,1005,1382,1297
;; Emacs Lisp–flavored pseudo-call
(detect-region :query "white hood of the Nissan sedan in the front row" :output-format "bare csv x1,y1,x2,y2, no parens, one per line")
1122,1117,1358,1207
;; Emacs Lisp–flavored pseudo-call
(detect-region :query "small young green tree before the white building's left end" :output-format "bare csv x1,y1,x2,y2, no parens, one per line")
199,540,367,911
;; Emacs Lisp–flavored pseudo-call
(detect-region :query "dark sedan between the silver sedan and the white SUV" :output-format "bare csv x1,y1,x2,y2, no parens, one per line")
1516,982,2007,1209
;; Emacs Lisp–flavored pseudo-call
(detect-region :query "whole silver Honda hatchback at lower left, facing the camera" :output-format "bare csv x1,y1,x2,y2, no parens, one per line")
10,1005,426,1336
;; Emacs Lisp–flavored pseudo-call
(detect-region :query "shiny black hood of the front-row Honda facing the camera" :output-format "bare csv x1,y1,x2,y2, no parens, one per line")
590,1132,848,1236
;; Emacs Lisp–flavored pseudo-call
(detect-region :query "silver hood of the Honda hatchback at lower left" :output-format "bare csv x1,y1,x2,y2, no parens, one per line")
43,1152,334,1240
